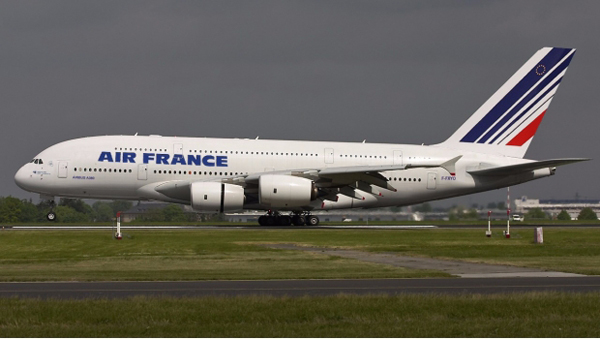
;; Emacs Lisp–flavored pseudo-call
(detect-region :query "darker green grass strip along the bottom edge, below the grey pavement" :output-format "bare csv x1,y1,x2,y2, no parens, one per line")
0,292,600,337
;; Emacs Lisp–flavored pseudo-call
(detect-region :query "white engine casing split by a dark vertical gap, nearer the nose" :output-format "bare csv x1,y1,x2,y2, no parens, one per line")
190,182,244,213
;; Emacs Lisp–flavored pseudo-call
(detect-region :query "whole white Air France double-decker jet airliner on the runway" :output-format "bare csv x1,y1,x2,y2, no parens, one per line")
15,47,588,225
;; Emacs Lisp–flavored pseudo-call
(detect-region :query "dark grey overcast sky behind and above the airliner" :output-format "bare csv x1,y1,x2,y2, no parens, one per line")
0,0,600,204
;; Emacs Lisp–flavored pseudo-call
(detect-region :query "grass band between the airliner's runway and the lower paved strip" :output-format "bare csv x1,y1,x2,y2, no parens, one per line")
0,228,600,281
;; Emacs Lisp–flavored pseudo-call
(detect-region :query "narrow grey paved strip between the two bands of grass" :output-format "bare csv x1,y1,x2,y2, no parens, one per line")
0,276,600,299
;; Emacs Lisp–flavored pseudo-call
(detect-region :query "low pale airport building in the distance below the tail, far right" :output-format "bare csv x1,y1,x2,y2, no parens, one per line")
514,196,600,220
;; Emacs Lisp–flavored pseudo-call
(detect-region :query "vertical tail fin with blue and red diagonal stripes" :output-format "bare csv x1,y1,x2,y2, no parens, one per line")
438,47,575,158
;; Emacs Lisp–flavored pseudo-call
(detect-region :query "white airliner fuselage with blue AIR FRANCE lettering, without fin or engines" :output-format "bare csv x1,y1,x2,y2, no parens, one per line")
15,136,551,209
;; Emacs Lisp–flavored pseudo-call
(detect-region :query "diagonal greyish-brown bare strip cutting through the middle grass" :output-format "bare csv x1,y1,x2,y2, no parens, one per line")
264,244,583,278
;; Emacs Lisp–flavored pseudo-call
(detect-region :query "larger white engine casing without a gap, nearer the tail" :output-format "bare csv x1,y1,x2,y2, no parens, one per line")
258,174,317,208
